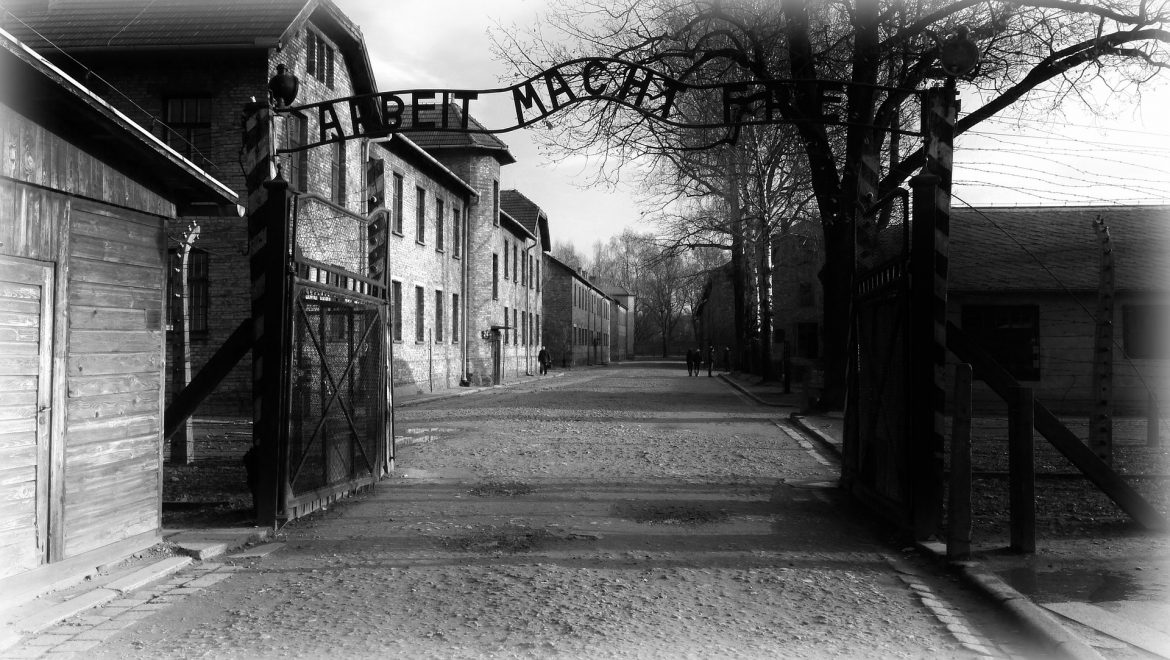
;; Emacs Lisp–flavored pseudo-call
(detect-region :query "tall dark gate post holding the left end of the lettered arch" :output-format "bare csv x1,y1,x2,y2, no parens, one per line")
242,103,291,525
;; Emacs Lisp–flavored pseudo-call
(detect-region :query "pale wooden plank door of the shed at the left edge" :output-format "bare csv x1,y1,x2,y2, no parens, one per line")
0,256,53,578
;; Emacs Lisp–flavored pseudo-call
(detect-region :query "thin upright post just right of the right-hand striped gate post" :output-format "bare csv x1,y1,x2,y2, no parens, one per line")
947,363,972,559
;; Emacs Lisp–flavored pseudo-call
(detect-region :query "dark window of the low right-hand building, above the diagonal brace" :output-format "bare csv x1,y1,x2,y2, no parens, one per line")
961,304,1040,380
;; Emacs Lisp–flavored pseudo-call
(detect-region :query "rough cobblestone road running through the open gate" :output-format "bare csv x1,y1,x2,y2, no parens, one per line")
4,364,1030,659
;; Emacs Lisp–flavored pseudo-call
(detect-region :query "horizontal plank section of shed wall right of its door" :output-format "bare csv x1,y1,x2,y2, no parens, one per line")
63,201,166,556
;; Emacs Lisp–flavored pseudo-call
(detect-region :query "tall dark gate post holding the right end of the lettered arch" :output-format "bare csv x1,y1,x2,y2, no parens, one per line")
909,78,958,539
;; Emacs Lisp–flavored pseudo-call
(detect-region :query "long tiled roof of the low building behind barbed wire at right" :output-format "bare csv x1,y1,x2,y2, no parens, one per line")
949,206,1170,291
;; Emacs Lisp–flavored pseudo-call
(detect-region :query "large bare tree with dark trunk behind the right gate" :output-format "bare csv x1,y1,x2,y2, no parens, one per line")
500,0,1170,405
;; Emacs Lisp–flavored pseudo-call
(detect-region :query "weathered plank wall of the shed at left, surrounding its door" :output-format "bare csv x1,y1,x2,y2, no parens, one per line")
0,105,174,566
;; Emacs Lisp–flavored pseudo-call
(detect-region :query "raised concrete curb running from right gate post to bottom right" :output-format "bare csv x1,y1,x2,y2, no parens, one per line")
918,543,1104,660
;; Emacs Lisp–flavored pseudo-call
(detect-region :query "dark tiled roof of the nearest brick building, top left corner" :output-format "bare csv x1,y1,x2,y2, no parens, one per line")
0,0,311,50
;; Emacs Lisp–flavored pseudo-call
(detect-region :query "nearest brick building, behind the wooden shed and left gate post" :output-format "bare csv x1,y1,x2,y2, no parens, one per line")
0,0,377,414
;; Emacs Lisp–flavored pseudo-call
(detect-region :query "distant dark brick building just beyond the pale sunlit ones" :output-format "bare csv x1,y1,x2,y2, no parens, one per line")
544,254,613,366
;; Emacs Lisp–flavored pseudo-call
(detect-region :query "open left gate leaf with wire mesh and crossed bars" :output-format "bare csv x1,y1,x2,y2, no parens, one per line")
283,195,392,518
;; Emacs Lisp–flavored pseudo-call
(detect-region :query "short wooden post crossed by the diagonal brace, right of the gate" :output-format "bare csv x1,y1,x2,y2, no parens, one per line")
1007,387,1035,552
